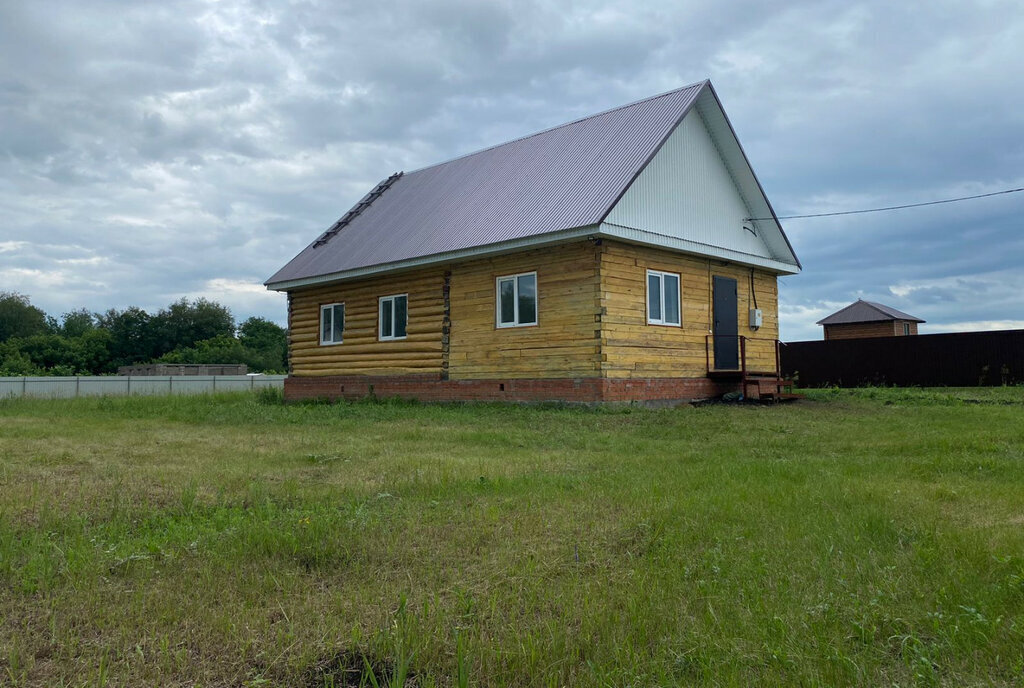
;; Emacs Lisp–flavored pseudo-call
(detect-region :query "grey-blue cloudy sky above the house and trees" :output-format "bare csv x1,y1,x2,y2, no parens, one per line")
0,0,1024,340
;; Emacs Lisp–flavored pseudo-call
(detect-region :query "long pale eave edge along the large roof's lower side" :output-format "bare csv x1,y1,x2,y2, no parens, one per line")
266,225,598,292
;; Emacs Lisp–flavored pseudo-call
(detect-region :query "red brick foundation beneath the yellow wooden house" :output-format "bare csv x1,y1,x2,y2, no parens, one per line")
285,375,739,405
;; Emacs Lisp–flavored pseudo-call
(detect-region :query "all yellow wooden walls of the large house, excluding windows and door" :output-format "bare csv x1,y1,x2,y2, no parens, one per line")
289,241,778,380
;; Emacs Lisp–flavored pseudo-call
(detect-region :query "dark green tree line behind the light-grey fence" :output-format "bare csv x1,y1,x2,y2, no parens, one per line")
0,292,288,377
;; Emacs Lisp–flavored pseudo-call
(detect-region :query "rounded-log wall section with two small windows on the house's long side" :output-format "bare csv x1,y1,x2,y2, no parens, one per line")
288,267,444,377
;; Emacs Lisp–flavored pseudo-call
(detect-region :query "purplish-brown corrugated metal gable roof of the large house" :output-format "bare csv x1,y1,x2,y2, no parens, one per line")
266,81,800,290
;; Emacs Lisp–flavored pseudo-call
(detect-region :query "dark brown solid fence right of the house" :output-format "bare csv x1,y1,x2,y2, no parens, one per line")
780,330,1024,387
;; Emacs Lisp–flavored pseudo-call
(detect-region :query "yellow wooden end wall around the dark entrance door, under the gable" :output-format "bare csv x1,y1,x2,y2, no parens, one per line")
599,241,778,378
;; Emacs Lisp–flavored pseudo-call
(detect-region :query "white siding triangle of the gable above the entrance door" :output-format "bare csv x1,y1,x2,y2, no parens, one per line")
604,109,778,263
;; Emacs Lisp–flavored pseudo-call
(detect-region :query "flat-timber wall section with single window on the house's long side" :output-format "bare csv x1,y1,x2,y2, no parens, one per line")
449,242,600,380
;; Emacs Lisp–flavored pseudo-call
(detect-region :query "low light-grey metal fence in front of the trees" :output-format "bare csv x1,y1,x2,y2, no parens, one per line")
0,375,287,399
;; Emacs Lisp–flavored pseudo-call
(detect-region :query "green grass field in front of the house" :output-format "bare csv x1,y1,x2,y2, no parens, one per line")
0,388,1024,687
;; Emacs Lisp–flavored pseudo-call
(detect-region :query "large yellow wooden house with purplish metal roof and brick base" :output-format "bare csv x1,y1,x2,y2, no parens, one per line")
266,81,801,402
